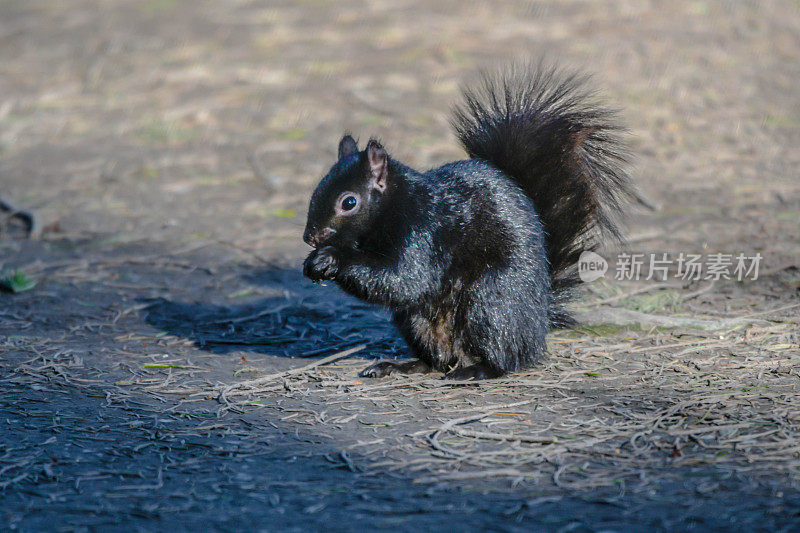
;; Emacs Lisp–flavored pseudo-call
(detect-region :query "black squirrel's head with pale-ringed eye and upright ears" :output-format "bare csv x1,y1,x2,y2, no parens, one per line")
303,135,389,248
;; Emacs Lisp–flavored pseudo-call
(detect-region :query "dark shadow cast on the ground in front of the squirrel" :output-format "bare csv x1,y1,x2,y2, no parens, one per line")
146,268,405,357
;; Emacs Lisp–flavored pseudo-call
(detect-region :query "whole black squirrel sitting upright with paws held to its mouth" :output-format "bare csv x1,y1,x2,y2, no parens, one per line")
303,63,638,379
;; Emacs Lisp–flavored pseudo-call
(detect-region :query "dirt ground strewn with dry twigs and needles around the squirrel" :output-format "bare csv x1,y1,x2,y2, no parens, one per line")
0,0,800,531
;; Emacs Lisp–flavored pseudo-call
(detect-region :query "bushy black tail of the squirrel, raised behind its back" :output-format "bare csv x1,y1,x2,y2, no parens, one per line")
451,62,638,327
